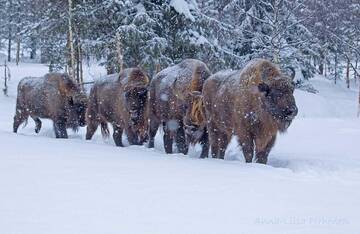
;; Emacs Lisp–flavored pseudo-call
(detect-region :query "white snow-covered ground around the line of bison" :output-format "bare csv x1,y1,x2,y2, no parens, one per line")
0,64,360,234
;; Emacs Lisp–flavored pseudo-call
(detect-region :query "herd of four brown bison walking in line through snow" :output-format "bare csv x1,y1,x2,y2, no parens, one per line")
13,59,297,164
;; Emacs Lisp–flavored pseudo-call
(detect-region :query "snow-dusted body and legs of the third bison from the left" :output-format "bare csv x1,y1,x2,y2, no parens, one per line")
149,59,211,155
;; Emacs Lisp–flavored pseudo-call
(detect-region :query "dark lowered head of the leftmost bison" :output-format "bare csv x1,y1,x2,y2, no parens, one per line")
67,93,87,130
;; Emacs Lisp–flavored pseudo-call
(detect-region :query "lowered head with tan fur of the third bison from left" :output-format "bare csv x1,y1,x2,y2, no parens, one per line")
183,91,206,144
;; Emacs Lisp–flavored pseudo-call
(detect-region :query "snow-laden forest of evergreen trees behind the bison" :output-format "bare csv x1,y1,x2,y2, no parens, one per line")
0,0,360,86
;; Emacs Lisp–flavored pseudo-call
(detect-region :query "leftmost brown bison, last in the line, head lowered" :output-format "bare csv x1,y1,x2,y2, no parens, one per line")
13,73,87,138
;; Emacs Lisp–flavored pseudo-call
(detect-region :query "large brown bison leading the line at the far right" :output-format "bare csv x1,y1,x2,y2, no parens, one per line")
187,59,298,164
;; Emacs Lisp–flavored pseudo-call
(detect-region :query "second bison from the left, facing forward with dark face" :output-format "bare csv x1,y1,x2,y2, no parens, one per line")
86,68,149,146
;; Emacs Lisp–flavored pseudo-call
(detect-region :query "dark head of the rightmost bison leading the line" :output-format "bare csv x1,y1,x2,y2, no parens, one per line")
258,76,298,132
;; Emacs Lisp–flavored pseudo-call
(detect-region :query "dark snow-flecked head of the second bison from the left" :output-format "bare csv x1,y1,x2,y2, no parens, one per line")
125,87,148,125
